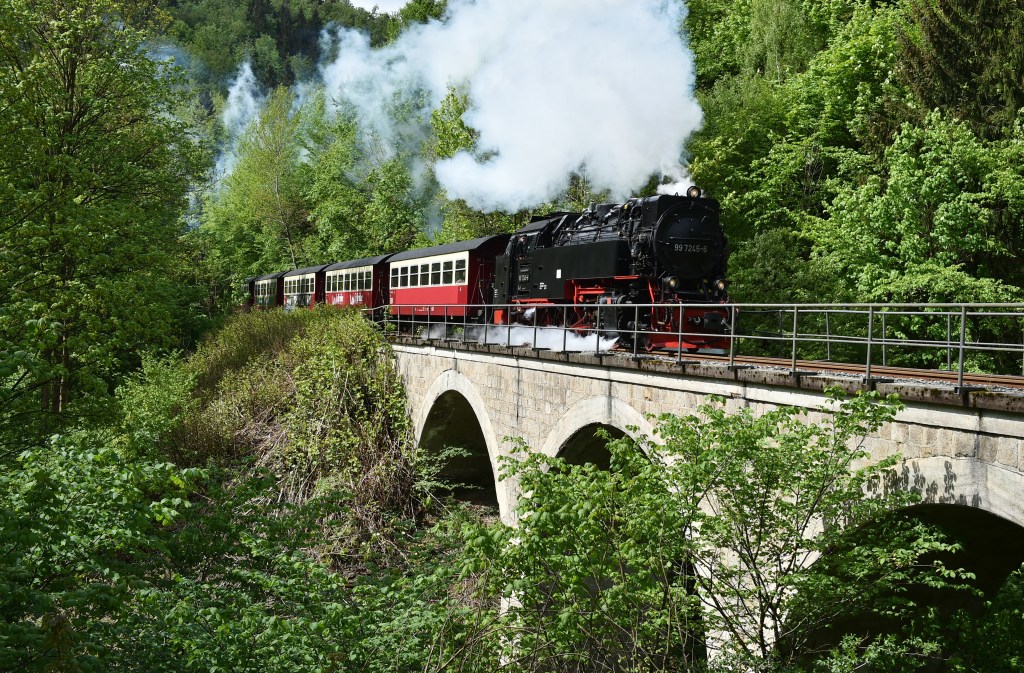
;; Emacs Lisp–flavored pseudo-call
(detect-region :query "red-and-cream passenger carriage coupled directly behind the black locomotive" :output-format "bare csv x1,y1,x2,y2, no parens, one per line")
388,234,509,320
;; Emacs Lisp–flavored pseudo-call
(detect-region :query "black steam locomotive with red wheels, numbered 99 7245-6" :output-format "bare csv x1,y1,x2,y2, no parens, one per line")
494,187,729,351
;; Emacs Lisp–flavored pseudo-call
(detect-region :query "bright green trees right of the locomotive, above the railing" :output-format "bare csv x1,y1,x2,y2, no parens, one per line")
690,2,1024,301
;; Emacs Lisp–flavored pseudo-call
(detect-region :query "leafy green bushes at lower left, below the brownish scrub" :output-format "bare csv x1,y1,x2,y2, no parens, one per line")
0,433,483,673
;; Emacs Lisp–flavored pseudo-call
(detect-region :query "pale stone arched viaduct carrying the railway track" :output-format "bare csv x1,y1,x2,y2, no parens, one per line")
393,338,1024,586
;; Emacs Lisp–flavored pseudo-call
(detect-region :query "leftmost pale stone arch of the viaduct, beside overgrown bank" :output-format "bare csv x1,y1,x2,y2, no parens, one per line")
414,369,512,520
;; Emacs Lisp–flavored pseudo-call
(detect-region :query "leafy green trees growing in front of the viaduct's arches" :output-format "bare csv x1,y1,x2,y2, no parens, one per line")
468,394,965,671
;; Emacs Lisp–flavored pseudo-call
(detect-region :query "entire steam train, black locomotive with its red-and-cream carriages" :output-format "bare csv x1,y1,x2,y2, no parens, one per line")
247,187,729,351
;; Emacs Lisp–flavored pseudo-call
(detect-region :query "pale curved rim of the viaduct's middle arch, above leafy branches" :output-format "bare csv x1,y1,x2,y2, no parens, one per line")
541,395,653,457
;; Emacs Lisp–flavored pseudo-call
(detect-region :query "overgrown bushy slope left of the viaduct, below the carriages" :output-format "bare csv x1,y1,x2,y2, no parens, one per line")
0,311,497,673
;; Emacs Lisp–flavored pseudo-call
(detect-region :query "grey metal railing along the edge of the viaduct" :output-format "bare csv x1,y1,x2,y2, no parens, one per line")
383,303,1024,387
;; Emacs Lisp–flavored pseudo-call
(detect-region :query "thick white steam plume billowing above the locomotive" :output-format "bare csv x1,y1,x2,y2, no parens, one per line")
322,0,701,211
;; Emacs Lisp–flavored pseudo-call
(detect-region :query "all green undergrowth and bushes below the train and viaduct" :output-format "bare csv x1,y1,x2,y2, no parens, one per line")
0,308,1021,673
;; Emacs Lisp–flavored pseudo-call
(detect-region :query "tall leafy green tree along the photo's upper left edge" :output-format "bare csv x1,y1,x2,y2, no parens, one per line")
0,0,200,446
